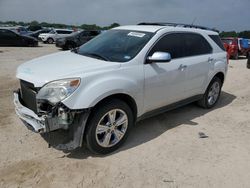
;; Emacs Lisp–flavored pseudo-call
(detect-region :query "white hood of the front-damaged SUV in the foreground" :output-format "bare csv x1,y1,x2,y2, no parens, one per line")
16,51,120,87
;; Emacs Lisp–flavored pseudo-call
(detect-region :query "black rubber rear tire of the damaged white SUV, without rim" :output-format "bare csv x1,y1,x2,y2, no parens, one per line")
198,77,222,109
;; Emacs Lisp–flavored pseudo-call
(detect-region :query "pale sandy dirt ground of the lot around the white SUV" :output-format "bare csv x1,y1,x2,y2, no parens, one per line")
0,44,250,188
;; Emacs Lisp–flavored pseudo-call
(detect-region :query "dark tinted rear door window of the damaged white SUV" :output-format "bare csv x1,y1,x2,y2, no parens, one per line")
183,33,212,56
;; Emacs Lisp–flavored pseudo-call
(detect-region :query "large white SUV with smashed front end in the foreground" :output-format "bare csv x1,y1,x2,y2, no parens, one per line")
14,23,228,154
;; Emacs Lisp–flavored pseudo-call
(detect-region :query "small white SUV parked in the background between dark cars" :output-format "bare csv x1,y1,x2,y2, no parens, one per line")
38,29,73,44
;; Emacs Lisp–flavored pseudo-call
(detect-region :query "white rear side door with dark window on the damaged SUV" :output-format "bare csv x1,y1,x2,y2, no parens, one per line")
182,33,214,97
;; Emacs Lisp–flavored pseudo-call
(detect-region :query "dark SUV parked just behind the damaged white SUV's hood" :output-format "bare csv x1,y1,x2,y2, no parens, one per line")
56,30,101,50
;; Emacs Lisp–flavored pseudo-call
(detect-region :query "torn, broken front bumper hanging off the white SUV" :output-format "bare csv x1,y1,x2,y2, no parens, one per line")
14,91,90,150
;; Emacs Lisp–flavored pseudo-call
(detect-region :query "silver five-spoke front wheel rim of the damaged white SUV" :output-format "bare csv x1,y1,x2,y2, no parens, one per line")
95,109,128,148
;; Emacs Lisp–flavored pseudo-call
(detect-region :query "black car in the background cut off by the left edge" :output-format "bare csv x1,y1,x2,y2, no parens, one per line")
0,28,38,46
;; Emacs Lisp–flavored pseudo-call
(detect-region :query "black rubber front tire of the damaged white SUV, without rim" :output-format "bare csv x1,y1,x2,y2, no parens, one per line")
85,99,134,154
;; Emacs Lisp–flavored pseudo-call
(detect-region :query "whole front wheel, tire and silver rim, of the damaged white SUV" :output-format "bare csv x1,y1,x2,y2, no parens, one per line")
86,99,134,154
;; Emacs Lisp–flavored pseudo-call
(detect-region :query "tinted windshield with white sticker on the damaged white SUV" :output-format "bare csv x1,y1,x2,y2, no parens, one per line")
74,30,153,62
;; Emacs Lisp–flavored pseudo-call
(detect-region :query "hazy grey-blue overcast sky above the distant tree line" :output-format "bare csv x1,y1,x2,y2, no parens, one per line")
0,0,250,31
